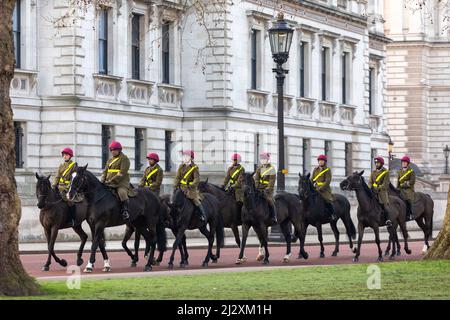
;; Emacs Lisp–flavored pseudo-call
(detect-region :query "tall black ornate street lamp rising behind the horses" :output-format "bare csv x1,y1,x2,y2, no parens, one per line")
269,12,294,191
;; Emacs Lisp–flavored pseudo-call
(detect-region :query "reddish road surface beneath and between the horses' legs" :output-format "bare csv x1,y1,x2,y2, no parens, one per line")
21,241,423,278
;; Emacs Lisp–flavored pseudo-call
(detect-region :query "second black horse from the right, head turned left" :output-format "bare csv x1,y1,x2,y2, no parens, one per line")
340,170,411,262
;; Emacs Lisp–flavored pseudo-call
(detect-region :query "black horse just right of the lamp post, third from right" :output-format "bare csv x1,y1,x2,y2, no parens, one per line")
298,173,356,259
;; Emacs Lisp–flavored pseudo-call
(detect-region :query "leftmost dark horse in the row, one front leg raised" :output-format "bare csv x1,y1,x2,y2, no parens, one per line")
36,173,88,271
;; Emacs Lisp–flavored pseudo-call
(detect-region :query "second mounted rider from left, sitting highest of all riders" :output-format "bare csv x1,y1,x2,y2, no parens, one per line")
101,141,135,221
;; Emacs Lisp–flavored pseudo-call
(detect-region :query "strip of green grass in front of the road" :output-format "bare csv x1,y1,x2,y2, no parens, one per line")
3,260,450,299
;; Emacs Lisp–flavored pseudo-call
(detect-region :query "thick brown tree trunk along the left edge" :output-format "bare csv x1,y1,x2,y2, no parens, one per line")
0,0,39,296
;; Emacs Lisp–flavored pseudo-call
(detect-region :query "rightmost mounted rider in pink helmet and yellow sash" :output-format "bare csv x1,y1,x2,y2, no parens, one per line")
397,156,416,220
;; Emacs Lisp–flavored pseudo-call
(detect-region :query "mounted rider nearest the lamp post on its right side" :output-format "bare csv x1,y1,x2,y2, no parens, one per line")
311,154,336,221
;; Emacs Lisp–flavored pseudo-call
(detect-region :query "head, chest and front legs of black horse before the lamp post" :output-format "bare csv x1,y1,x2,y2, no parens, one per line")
236,173,273,264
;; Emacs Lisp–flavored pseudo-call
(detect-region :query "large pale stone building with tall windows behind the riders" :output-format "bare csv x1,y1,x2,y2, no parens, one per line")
11,0,389,238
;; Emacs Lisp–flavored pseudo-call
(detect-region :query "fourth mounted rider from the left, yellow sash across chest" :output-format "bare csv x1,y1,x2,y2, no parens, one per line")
173,150,206,222
